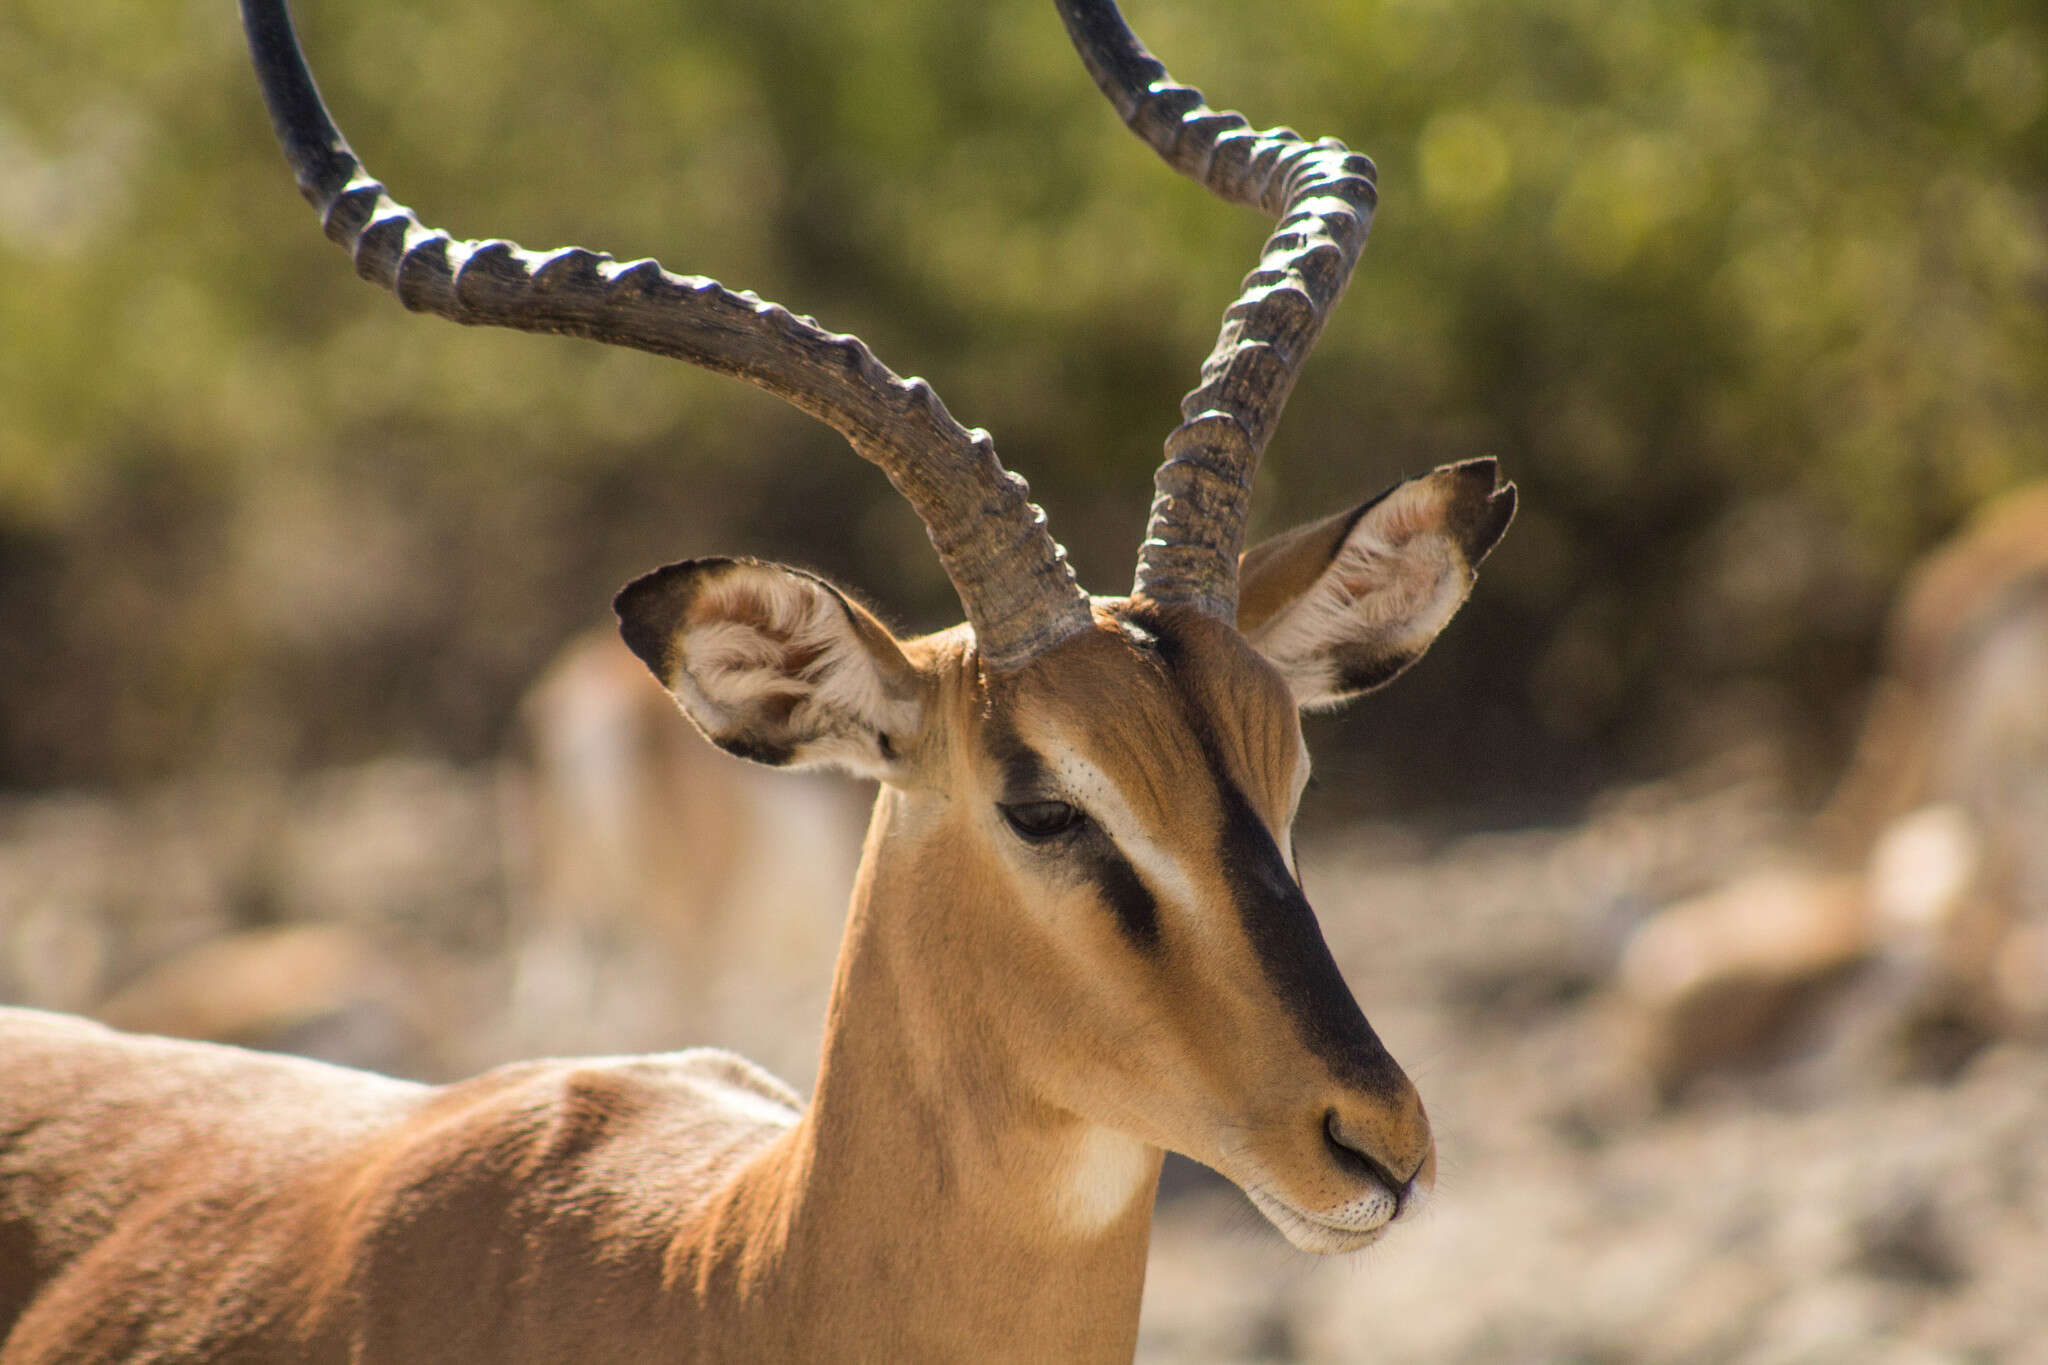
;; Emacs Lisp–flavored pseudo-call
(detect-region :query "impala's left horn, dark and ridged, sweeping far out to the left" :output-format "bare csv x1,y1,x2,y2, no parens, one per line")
242,0,1090,669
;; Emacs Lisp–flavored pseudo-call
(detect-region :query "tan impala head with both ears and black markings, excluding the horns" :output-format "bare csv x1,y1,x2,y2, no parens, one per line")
616,460,1513,1250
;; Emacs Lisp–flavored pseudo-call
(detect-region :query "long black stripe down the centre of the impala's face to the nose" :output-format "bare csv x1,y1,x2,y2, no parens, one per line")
1133,605,1405,1099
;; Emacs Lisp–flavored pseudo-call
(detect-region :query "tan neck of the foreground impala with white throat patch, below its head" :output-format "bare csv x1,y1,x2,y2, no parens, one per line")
700,786,1159,1361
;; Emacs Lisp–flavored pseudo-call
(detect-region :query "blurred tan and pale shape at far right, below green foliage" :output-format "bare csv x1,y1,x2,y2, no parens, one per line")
1614,485,2048,1095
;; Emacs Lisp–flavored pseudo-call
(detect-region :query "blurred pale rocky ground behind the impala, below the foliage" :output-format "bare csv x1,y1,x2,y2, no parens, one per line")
0,763,2048,1365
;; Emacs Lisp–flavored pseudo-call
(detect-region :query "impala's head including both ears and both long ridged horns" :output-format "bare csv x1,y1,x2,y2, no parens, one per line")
244,0,1513,1250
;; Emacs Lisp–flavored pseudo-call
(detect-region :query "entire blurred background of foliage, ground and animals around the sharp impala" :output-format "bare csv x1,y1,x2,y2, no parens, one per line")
0,0,2048,1361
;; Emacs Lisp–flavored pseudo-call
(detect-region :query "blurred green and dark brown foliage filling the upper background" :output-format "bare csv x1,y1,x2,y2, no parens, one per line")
0,0,2048,817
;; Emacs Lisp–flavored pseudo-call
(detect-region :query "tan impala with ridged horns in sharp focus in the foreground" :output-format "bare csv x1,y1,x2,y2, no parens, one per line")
0,0,1513,1365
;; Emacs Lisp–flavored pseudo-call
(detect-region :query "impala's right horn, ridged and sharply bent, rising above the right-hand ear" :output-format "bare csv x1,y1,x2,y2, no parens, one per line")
1057,0,1378,620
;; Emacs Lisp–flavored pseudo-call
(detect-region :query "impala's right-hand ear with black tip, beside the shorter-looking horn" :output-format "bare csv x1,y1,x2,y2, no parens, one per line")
1237,458,1516,708
